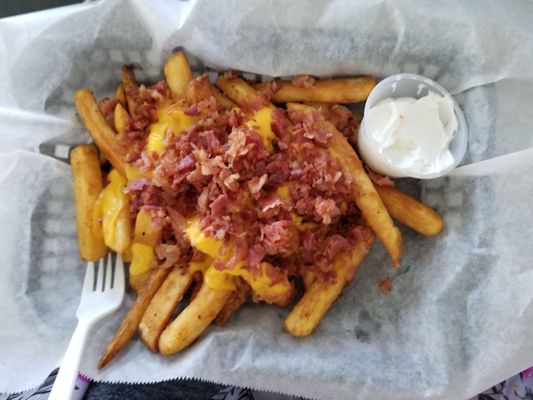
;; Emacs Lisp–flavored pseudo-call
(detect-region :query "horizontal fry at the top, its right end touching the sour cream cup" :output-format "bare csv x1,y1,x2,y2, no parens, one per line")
255,76,376,103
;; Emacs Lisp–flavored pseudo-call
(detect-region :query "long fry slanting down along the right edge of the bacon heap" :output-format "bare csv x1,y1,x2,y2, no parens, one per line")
287,103,402,268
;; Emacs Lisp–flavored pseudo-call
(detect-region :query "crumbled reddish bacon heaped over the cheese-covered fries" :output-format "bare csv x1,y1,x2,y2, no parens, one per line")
121,91,376,282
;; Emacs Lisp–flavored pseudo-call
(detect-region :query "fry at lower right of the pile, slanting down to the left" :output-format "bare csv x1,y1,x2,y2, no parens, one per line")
284,229,374,336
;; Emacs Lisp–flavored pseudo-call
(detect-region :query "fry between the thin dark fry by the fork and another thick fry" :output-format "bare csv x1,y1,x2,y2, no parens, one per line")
139,267,193,352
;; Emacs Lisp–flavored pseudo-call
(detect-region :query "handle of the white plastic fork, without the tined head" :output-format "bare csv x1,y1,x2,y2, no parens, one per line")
48,320,92,400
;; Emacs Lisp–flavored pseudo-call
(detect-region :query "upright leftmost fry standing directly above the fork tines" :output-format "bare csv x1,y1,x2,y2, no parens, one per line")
70,144,107,261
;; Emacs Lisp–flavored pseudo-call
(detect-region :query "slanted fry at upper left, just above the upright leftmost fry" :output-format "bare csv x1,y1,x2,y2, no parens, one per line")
76,89,126,176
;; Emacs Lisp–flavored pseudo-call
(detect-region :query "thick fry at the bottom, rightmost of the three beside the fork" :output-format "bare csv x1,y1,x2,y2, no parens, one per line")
159,282,232,355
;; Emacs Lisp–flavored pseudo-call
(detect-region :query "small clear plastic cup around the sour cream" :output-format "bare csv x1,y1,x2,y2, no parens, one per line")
357,74,468,179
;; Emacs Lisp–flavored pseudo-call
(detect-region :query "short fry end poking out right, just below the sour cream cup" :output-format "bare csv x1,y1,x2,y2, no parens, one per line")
376,185,444,236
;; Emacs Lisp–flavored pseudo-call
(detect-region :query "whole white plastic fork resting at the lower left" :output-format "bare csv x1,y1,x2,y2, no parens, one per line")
48,253,125,400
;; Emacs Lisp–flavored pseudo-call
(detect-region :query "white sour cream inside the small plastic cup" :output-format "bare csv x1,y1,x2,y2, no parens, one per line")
365,92,457,174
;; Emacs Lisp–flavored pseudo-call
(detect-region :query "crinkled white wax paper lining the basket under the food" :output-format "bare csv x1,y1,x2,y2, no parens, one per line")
0,0,533,400
